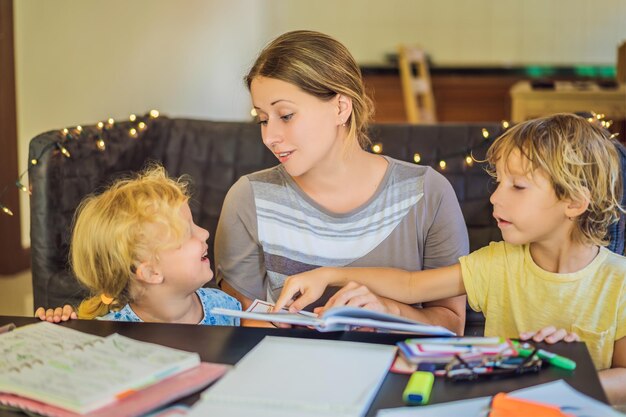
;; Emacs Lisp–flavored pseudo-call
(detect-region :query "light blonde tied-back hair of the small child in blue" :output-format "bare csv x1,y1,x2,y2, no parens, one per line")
70,165,189,318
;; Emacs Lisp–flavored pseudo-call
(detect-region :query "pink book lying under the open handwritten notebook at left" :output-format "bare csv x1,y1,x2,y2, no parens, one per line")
0,362,231,417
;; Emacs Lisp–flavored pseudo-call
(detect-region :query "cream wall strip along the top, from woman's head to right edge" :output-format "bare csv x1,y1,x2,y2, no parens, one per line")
267,0,626,65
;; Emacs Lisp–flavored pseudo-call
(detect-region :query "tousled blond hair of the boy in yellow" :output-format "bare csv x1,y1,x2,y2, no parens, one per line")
487,113,623,246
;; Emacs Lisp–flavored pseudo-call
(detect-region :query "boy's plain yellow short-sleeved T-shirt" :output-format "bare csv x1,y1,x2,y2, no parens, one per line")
459,242,626,370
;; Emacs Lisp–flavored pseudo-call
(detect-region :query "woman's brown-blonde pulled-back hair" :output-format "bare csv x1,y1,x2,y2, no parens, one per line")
245,30,374,148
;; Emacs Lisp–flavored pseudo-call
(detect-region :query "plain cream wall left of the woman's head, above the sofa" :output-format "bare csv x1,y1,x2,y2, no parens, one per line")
14,0,267,246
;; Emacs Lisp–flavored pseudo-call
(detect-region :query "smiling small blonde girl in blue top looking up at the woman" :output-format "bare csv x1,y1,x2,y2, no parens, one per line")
36,165,241,325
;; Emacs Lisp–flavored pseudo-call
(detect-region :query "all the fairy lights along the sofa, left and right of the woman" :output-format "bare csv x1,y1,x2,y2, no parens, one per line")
0,110,617,216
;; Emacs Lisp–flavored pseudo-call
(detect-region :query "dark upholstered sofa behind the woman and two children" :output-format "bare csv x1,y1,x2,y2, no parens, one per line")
29,116,502,333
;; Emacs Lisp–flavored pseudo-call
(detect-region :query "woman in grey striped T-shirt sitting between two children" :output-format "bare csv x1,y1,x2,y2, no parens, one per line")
215,31,469,333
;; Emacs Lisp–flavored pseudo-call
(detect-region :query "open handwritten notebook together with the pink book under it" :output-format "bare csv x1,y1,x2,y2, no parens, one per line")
0,322,228,416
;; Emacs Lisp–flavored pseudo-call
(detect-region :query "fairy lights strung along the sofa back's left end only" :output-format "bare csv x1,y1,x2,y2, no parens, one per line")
0,110,159,216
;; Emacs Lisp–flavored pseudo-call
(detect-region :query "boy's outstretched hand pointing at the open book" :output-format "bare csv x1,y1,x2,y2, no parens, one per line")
272,267,328,313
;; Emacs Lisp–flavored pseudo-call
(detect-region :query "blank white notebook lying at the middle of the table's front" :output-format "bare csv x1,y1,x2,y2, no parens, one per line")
190,336,396,417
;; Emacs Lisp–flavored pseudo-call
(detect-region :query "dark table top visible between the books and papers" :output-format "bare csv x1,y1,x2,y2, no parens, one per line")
0,316,608,416
